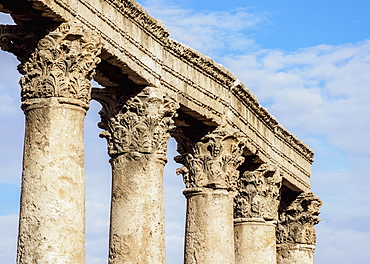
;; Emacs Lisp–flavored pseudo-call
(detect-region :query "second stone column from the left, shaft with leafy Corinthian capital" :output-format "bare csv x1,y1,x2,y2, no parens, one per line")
94,87,178,264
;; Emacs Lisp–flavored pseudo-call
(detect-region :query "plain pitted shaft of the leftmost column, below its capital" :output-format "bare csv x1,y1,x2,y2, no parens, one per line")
17,98,86,264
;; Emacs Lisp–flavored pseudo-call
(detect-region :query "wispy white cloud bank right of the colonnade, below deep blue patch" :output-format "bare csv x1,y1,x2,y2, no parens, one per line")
137,1,370,264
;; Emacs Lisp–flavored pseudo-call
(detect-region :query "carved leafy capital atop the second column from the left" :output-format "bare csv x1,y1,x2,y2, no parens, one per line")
99,87,179,159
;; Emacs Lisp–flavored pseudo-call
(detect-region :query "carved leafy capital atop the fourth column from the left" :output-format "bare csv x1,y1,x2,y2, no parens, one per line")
234,164,282,220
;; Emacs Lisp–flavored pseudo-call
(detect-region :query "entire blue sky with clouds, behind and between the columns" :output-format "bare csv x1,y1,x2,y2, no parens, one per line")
0,0,370,264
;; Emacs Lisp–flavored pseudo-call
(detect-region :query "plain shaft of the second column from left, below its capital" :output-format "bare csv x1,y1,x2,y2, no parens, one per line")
109,153,166,264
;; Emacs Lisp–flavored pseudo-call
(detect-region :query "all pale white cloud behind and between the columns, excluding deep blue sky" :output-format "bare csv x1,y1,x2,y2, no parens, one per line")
0,0,370,264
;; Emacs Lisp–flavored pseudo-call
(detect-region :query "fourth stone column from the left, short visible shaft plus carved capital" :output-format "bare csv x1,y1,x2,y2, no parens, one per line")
234,164,282,264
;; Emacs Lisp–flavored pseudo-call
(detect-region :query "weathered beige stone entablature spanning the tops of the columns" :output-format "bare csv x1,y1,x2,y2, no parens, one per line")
0,0,313,191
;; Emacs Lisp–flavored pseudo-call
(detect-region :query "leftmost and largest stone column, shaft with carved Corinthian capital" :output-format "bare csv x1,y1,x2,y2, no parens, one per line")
1,24,101,264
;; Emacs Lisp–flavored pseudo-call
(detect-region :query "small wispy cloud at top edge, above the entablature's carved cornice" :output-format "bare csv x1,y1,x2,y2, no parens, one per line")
137,0,269,58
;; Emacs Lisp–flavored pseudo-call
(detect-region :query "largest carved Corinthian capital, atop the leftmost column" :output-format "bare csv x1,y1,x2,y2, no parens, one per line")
10,23,102,104
